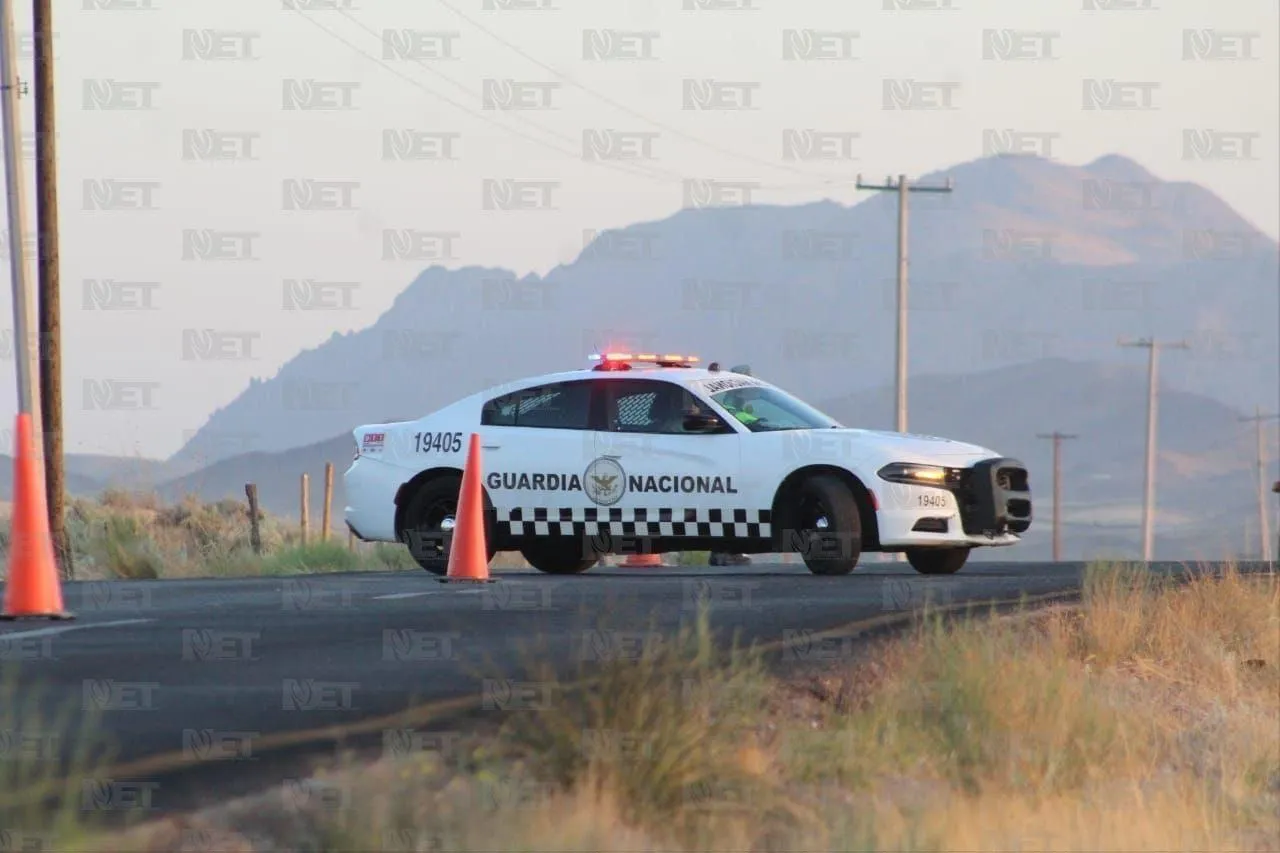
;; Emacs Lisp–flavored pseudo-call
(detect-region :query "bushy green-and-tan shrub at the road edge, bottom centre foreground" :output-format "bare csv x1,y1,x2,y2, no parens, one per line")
494,604,791,840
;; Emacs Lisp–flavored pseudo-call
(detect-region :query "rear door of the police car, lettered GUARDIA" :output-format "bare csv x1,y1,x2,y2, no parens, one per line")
480,379,600,535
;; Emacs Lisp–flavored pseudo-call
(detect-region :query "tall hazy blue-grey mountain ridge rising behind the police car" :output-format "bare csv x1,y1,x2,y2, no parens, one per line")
174,156,1280,465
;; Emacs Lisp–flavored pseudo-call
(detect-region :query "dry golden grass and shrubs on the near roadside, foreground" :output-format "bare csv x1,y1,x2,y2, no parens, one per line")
55,565,1280,853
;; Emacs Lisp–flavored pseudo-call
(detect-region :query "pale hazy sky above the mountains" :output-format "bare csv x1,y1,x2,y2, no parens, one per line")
0,0,1280,457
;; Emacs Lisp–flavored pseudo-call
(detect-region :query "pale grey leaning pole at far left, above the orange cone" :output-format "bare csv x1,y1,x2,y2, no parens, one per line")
0,0,44,438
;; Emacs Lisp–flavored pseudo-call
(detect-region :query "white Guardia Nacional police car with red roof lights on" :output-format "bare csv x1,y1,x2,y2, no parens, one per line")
343,353,1032,575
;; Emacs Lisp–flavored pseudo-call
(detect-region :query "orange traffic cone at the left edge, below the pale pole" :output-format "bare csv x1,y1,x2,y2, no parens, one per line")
0,412,74,620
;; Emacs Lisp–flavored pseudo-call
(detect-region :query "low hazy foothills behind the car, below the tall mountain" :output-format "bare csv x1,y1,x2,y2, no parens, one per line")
0,359,1249,560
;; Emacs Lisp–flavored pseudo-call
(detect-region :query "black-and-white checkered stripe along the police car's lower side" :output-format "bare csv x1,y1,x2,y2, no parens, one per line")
497,506,771,539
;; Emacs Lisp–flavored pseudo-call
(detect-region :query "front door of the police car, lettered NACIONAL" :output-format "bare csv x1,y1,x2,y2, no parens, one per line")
582,378,746,537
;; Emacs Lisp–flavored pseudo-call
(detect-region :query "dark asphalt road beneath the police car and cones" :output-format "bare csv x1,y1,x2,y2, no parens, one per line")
0,562,1259,811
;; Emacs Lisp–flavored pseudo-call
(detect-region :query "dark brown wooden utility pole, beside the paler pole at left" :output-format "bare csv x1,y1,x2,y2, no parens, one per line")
32,0,76,580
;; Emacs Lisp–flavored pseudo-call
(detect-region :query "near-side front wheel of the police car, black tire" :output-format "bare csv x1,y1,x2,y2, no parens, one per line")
791,474,863,575
